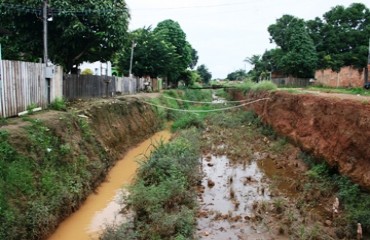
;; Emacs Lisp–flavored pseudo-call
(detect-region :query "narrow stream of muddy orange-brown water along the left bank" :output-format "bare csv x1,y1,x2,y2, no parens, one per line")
48,130,171,240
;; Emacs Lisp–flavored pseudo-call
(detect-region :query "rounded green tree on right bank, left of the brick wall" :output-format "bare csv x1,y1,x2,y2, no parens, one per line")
268,15,318,77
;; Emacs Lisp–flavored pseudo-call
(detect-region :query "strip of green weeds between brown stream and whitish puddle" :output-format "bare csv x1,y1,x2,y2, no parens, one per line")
101,128,201,240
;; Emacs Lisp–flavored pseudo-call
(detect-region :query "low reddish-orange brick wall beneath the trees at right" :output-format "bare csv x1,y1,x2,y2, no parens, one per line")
315,67,365,87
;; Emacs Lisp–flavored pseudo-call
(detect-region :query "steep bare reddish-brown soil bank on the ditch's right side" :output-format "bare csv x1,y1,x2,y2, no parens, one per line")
230,90,370,189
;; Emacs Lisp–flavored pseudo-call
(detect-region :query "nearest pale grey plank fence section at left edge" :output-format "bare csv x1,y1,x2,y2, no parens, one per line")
0,60,50,117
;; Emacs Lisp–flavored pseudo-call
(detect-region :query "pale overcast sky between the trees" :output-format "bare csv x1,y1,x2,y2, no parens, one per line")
126,0,369,78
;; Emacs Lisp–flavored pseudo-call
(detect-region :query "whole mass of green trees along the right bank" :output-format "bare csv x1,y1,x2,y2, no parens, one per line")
247,3,370,80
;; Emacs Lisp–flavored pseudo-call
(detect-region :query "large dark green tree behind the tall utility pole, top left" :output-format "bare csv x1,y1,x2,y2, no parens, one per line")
0,0,129,72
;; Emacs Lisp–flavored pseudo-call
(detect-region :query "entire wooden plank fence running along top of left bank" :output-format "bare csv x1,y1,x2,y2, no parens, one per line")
0,60,161,118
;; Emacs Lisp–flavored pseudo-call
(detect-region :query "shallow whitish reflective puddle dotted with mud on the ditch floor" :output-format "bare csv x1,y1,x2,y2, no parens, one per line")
197,156,271,239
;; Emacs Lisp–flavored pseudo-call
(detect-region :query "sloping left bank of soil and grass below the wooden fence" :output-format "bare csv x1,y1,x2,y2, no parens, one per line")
0,99,161,239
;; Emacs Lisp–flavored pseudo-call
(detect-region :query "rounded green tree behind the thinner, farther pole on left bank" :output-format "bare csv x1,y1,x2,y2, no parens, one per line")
118,20,198,85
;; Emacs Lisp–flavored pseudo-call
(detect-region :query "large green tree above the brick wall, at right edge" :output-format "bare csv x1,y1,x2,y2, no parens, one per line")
307,3,370,71
